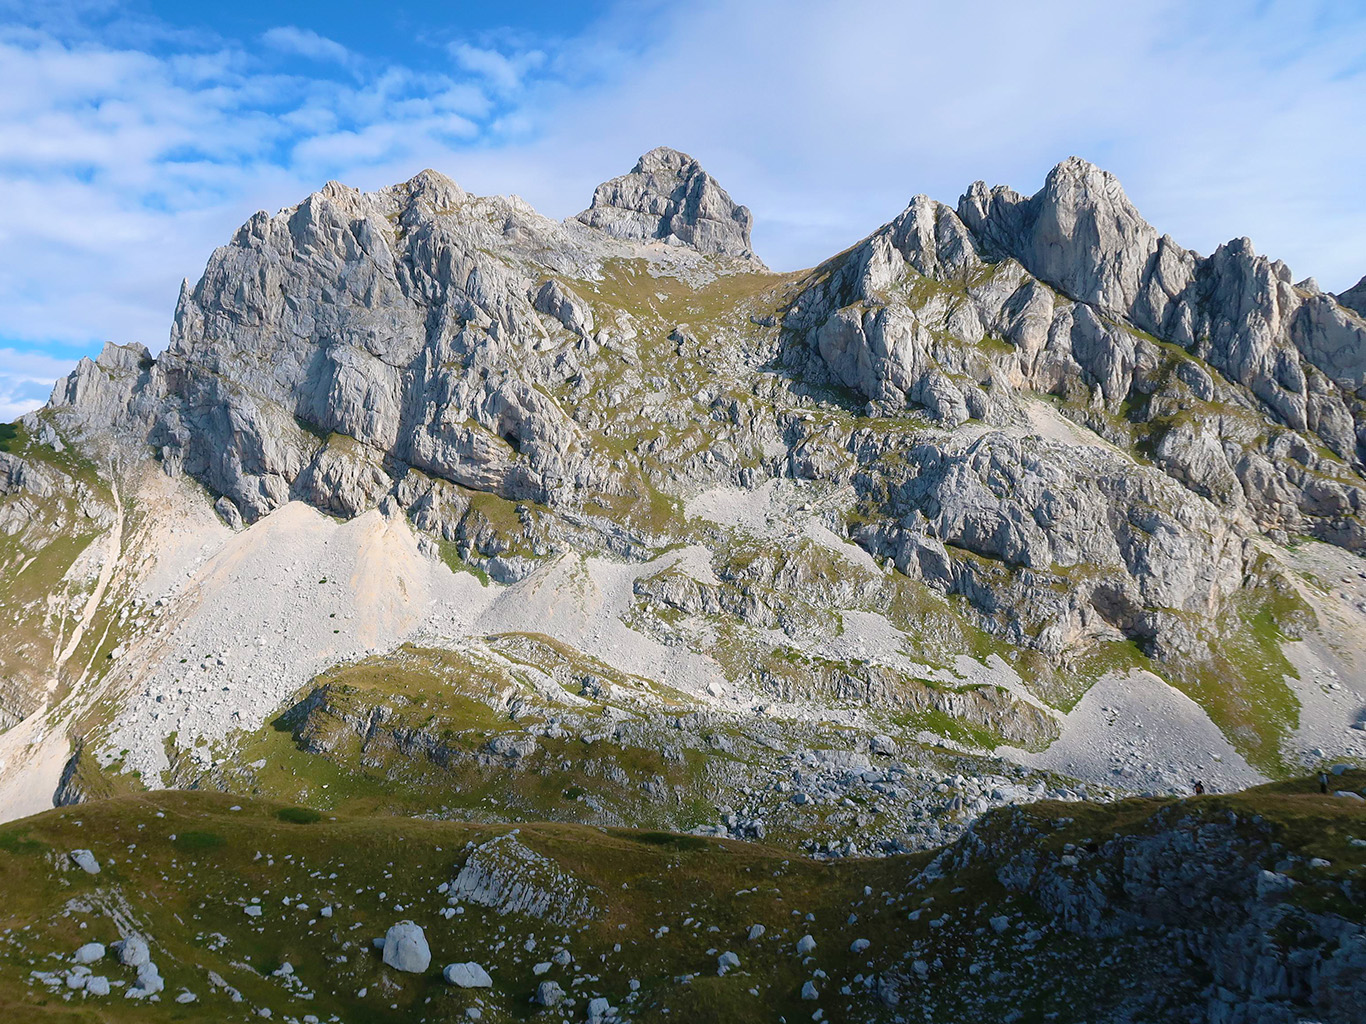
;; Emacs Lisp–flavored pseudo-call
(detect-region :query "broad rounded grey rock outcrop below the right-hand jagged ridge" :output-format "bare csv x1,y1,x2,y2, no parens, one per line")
863,434,1254,654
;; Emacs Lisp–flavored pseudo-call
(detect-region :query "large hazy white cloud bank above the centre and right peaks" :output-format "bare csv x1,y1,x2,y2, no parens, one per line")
463,0,1366,289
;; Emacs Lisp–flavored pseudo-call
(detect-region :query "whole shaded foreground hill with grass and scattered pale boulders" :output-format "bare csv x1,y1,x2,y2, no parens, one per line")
0,771,1366,1024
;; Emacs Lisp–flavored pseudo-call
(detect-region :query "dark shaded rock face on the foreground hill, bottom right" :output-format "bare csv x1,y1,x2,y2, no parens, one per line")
908,812,1366,1024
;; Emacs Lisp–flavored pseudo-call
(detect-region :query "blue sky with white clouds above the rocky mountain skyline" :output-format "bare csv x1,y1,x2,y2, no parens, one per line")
0,0,1366,422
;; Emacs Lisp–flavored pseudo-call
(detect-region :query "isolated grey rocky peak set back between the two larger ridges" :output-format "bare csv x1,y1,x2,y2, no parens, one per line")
576,146,758,262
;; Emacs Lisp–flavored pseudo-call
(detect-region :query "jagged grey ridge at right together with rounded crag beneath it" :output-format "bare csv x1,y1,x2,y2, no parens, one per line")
785,158,1366,653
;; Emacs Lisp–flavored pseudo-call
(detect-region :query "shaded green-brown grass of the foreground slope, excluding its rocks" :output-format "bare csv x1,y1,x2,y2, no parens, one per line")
0,773,1366,1021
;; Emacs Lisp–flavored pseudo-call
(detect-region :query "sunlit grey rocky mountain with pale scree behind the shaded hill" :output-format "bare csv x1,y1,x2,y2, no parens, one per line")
0,149,1366,1021
